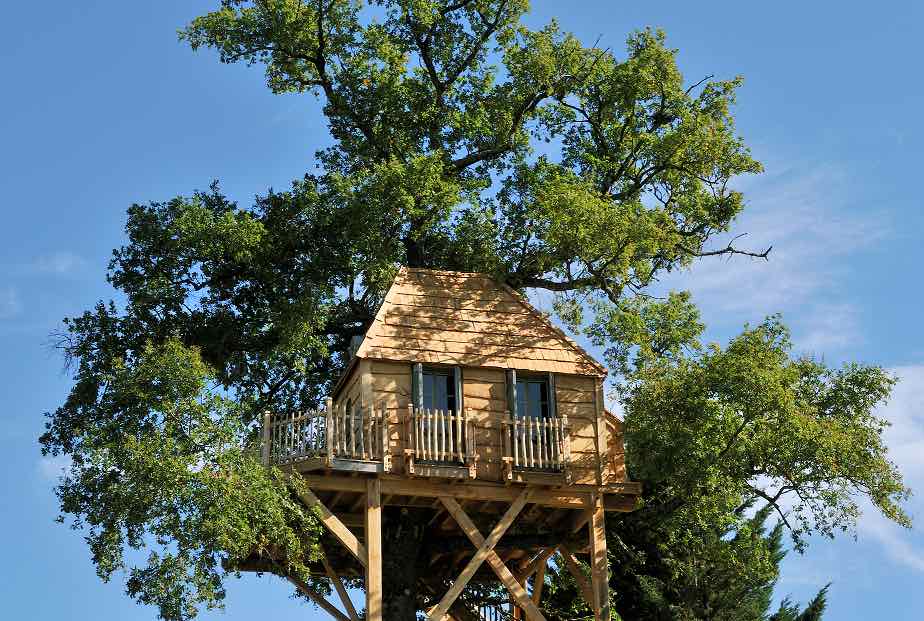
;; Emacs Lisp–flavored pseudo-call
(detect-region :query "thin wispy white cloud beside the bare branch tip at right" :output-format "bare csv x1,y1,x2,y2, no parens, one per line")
664,160,892,350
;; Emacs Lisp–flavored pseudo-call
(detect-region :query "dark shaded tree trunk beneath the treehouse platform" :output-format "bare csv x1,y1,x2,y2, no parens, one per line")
382,507,433,621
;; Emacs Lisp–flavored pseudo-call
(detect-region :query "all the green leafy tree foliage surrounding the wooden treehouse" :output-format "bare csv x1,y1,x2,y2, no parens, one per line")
42,0,906,619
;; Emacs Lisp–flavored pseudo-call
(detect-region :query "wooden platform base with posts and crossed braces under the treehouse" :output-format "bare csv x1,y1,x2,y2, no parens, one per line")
243,468,639,621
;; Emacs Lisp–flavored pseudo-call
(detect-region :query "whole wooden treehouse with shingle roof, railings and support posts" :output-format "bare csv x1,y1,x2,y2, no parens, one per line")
263,268,639,621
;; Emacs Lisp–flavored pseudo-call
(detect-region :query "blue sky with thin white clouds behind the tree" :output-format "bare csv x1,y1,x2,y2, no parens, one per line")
0,0,924,621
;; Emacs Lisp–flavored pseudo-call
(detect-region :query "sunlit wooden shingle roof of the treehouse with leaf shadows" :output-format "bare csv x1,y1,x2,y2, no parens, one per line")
356,268,606,377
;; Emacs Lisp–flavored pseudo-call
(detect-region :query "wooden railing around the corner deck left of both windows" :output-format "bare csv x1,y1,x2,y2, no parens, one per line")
263,402,388,466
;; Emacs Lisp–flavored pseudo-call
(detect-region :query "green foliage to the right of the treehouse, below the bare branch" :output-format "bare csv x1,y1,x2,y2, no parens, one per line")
576,318,910,620
